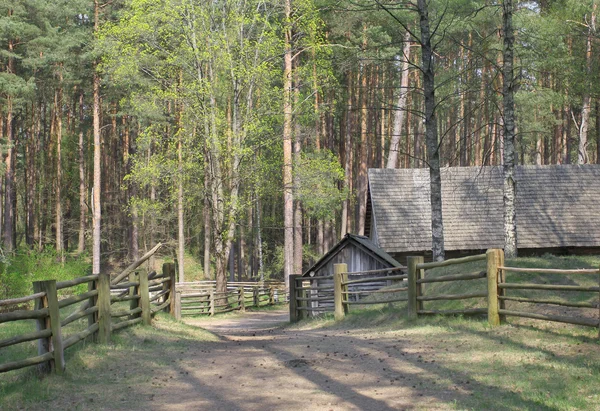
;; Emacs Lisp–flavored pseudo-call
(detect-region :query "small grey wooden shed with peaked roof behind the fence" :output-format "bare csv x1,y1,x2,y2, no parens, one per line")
303,234,406,315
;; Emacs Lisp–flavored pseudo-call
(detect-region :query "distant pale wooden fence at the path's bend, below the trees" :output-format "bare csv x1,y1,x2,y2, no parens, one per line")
175,281,287,319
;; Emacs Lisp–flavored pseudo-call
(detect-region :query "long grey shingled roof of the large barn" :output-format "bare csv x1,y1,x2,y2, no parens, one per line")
369,164,600,253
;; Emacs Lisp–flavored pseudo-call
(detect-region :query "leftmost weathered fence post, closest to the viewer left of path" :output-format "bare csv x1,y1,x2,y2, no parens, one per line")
33,280,65,375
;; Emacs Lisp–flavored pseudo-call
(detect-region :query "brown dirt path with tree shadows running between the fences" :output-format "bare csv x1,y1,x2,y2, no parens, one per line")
144,311,454,410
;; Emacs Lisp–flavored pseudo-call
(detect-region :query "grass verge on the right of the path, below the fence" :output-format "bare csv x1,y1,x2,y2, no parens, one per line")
296,304,600,410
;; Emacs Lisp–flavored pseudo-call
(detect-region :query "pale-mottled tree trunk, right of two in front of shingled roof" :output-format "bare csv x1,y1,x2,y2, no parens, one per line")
502,0,517,258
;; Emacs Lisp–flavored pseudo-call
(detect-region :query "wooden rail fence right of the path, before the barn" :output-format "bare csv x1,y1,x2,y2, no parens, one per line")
290,249,600,338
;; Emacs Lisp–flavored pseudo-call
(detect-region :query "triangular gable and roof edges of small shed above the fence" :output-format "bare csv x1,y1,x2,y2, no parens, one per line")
303,233,401,277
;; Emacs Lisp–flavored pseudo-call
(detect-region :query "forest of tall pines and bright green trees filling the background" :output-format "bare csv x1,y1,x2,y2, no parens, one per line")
0,0,600,291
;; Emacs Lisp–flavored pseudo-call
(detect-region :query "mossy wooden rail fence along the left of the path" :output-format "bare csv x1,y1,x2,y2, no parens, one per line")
0,264,175,374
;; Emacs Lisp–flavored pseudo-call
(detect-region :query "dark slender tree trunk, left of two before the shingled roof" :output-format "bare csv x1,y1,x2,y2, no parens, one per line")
417,0,445,261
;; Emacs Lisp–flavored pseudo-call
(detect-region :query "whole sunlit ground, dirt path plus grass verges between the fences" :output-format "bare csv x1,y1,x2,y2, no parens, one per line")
0,309,600,411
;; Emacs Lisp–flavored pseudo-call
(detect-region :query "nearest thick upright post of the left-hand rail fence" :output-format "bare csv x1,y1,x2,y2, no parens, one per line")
33,280,65,375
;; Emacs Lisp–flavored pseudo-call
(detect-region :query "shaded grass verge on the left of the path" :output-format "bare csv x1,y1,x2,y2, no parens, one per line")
0,313,219,410
